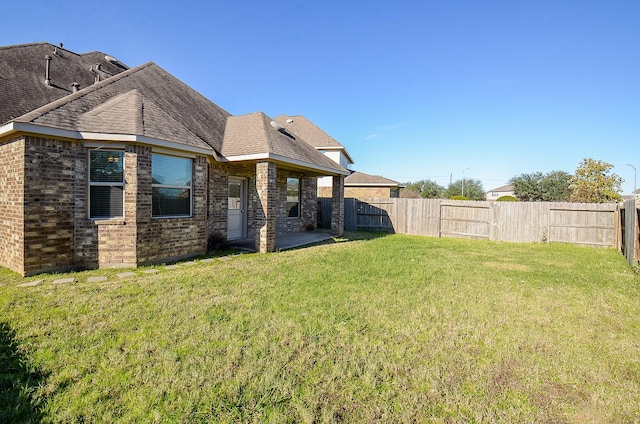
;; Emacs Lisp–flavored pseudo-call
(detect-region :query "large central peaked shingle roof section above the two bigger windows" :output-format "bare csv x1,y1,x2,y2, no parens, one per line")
16,63,229,152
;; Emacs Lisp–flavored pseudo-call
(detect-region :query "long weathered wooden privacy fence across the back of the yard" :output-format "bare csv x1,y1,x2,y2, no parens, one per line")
318,199,637,248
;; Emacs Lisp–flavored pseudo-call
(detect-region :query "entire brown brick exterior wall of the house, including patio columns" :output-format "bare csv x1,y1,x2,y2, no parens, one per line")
0,135,344,275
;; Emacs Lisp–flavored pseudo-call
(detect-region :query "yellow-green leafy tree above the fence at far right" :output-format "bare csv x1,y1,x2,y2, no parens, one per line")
569,158,624,203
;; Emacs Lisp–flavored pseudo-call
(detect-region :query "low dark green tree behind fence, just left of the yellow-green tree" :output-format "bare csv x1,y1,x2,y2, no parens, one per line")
509,171,571,202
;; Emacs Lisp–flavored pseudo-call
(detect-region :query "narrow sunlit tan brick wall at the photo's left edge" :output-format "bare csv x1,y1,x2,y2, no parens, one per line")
0,138,25,273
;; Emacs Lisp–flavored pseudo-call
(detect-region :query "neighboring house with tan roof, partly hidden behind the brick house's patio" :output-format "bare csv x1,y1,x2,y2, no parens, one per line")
274,115,353,197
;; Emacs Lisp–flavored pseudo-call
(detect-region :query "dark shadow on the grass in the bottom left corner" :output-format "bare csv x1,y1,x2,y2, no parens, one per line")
0,322,45,423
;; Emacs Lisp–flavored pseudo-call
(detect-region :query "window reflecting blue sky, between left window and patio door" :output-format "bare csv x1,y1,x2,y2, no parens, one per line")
151,154,192,217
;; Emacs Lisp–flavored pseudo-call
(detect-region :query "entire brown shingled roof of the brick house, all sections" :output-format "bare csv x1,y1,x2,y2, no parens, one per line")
0,43,349,175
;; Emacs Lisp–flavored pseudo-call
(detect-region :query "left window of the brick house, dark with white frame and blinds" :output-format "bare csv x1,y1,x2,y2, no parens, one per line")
89,150,124,219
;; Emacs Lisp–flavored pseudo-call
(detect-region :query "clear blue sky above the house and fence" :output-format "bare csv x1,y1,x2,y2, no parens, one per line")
6,0,640,194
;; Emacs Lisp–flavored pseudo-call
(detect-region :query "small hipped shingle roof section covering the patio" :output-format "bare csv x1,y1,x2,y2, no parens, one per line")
221,112,349,175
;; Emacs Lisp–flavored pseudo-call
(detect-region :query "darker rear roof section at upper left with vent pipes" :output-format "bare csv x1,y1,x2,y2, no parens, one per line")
0,43,128,125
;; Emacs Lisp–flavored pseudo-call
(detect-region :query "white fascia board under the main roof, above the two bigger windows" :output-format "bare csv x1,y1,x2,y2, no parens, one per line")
0,122,214,156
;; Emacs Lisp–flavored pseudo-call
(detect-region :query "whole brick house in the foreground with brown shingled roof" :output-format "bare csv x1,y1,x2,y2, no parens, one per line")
0,43,349,275
